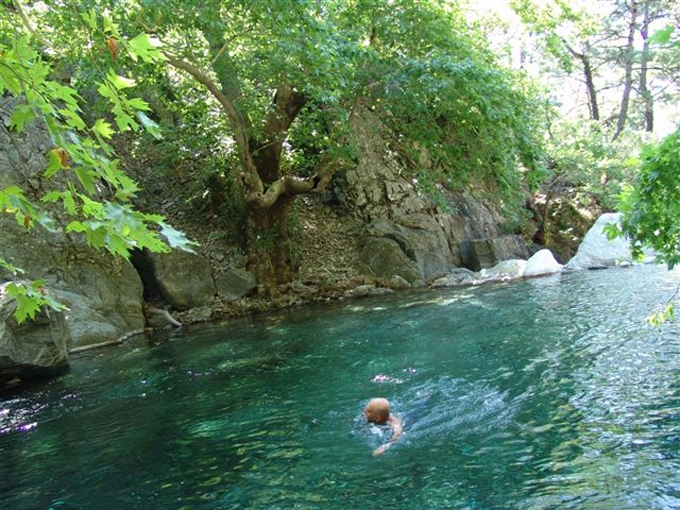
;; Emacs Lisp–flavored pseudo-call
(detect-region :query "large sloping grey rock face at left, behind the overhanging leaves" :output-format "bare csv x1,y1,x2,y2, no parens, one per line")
0,98,144,362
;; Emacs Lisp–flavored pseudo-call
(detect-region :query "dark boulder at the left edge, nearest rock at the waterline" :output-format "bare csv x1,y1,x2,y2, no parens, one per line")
0,284,70,383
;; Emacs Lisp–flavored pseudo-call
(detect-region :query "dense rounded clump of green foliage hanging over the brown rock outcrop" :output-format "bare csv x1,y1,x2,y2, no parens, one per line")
348,2,541,209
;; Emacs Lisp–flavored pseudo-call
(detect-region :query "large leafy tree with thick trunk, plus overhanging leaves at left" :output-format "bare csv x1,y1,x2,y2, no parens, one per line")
0,0,540,318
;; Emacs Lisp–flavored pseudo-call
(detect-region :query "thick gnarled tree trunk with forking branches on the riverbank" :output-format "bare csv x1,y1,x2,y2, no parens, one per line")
164,30,348,296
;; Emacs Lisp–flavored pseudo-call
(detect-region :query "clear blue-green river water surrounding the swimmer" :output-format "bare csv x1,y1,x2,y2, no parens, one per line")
0,267,680,510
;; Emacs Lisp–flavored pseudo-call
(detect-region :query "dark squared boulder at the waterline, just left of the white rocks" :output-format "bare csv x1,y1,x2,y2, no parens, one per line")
461,235,529,271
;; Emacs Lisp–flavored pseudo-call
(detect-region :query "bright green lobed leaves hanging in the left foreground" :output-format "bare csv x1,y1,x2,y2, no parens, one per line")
0,3,194,322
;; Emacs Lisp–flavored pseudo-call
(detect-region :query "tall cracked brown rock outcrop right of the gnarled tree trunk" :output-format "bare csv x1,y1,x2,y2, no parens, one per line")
334,110,528,282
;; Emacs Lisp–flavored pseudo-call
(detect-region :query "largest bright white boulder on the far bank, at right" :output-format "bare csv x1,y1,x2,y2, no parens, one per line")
565,213,633,270
